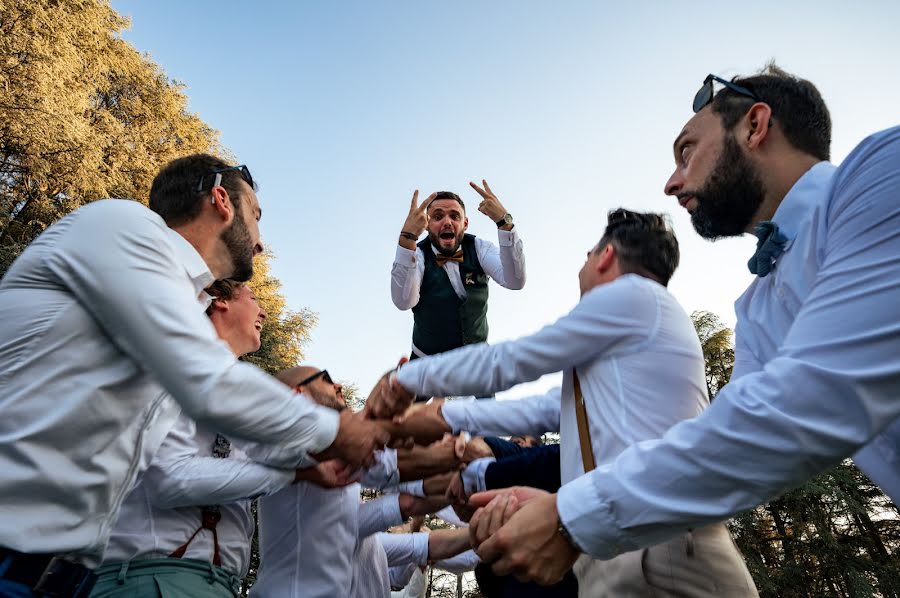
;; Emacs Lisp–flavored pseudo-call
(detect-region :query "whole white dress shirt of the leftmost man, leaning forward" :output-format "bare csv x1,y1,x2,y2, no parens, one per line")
0,200,337,567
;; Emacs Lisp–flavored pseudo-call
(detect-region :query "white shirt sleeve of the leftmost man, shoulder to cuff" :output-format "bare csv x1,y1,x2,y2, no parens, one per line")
46,201,338,467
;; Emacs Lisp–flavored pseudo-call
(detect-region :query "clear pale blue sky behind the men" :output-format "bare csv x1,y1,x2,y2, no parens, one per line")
112,0,900,404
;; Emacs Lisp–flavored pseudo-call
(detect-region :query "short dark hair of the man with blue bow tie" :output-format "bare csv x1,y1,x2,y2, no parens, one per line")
713,62,831,160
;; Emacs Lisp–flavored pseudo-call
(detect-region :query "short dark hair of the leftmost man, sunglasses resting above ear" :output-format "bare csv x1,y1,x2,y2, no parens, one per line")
150,154,246,226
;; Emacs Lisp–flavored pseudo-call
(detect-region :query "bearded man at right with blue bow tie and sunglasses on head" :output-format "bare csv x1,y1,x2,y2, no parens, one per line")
458,65,900,592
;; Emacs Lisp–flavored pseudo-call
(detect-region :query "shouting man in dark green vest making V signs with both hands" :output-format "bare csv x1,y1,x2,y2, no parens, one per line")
391,181,525,366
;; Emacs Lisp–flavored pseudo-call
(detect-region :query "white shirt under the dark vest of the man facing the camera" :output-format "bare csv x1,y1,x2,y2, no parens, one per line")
391,228,525,322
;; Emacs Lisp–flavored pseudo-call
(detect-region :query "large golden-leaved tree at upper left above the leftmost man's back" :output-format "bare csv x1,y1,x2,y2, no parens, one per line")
0,0,224,276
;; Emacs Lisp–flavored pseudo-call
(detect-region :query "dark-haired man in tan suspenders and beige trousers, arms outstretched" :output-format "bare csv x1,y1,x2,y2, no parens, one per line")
382,209,758,598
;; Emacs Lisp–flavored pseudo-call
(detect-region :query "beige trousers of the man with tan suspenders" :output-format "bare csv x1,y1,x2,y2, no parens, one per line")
574,523,759,598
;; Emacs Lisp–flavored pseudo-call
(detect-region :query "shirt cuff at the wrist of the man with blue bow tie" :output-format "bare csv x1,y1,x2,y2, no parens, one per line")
556,472,633,559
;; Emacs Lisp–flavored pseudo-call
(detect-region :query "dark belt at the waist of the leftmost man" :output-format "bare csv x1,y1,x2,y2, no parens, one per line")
0,546,96,598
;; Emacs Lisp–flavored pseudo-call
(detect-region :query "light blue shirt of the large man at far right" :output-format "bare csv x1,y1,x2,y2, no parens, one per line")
558,127,900,557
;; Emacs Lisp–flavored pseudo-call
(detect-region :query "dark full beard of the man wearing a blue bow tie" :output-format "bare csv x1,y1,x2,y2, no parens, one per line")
691,135,765,241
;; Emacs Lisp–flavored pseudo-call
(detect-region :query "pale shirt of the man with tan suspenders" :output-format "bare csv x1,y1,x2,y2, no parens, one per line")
397,274,708,556
